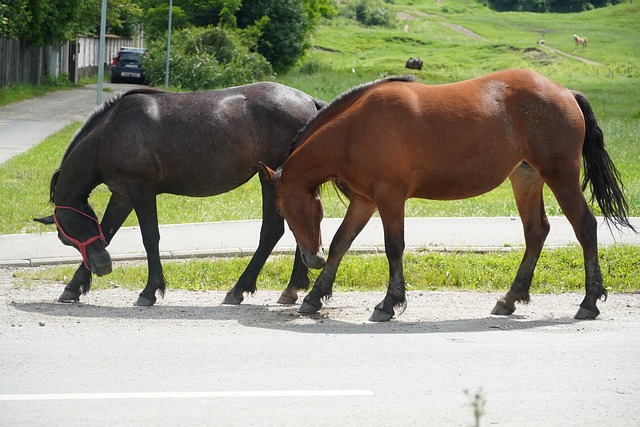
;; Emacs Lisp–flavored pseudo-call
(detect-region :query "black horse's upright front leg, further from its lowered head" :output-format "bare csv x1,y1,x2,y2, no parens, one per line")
132,191,166,306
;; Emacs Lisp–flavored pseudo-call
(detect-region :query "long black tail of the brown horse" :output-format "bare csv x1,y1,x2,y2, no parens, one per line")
573,92,637,232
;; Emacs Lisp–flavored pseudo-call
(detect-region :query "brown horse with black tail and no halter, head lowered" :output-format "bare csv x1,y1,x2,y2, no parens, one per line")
262,70,633,321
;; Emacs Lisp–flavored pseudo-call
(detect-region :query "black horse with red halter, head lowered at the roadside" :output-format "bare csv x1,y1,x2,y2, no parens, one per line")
36,82,324,306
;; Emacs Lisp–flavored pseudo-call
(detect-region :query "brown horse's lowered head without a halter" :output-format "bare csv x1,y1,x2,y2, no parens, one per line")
260,163,326,268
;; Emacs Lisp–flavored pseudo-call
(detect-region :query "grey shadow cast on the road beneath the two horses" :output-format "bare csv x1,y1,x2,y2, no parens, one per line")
10,302,589,335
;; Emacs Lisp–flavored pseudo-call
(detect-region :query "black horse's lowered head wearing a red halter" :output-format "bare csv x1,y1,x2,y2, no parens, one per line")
34,204,111,276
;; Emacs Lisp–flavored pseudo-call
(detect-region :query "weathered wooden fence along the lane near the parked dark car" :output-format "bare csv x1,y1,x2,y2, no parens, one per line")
0,36,143,87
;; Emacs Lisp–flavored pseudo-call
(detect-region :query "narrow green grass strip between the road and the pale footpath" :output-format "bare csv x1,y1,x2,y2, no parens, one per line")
15,245,640,293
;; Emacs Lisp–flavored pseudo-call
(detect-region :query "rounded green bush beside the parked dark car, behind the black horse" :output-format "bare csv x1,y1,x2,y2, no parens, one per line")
144,27,273,90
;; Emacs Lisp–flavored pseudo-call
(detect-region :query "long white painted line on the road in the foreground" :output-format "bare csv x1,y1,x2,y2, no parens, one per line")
0,390,374,401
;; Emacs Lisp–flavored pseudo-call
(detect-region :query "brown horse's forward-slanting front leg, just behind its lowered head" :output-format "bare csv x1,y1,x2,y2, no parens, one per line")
298,195,376,314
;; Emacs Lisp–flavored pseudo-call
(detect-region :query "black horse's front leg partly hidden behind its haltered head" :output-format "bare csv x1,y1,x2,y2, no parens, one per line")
58,194,133,302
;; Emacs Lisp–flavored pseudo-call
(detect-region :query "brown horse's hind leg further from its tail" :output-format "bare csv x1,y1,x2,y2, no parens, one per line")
491,163,549,315
